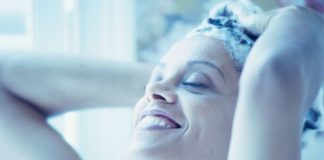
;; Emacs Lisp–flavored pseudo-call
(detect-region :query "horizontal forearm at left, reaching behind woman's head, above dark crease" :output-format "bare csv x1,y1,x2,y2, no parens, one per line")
0,54,152,114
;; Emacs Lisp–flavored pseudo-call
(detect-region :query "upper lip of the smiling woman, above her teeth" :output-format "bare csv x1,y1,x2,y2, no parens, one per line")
136,109,182,128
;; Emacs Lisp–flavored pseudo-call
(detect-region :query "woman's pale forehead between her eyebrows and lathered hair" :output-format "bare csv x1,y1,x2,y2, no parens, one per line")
161,36,232,66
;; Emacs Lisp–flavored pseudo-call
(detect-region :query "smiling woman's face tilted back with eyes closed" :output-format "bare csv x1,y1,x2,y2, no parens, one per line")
129,36,239,160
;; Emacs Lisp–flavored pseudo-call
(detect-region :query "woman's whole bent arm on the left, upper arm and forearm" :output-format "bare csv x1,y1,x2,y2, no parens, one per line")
0,54,151,160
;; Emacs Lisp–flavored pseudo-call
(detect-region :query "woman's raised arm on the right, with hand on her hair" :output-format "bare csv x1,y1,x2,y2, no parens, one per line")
229,6,324,160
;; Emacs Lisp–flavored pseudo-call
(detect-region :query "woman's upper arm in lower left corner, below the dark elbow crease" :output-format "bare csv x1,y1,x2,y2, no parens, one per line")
0,86,80,160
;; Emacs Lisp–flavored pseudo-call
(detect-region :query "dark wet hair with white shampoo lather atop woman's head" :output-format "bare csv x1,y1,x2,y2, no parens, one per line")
186,1,257,72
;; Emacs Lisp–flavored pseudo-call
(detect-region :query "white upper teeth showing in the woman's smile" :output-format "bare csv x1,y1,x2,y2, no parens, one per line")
137,116,173,129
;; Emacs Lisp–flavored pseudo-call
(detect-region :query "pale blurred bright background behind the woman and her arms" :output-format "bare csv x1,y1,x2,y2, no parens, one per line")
0,0,324,160
